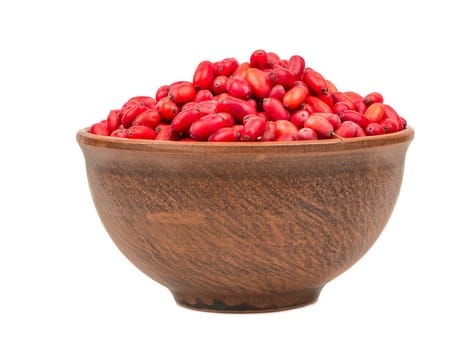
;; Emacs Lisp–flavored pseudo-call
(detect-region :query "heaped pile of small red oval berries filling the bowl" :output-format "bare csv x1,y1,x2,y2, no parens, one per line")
90,50,406,141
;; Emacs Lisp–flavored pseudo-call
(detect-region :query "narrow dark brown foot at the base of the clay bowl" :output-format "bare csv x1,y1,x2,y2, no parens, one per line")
173,287,323,313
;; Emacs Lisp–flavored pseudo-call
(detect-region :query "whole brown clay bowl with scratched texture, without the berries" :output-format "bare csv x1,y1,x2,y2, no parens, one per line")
77,128,414,312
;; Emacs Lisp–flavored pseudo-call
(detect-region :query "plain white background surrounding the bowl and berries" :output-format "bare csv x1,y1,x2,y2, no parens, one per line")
0,0,472,350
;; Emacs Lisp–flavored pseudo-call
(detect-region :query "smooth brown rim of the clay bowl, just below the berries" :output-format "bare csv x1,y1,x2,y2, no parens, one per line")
76,126,414,153
